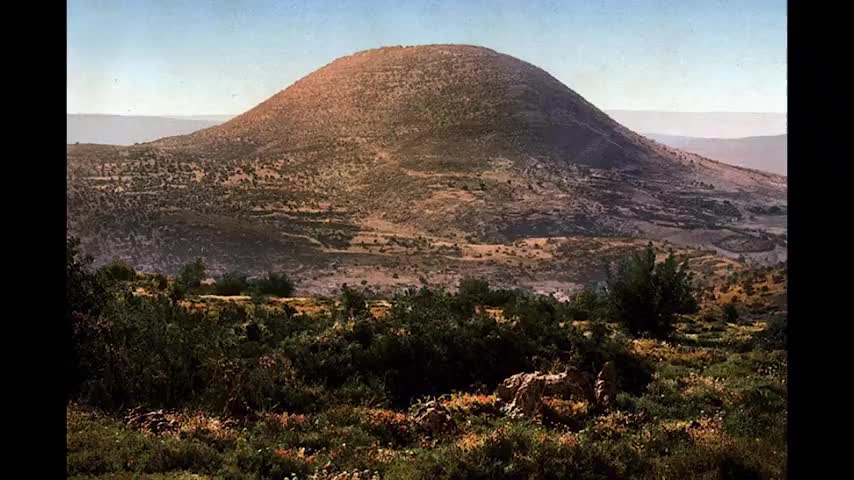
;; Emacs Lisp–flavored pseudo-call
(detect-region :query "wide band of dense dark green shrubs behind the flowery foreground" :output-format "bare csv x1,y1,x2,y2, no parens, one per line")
67,240,648,411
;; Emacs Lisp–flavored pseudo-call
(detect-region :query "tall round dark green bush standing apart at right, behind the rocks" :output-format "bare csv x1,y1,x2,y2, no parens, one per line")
607,243,697,337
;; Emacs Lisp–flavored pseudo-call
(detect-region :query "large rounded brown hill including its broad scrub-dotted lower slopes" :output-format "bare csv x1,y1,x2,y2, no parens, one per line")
67,45,786,284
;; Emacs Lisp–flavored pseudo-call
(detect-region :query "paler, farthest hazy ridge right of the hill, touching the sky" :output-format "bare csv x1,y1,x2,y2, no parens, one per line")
605,110,787,138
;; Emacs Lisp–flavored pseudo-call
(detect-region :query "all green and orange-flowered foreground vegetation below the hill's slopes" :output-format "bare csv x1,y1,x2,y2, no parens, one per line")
66,238,787,479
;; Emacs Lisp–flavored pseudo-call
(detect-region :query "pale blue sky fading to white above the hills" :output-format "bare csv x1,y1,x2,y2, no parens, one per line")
66,0,787,115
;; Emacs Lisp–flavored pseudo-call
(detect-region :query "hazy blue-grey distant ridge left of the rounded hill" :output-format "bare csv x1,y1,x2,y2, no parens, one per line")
65,114,224,145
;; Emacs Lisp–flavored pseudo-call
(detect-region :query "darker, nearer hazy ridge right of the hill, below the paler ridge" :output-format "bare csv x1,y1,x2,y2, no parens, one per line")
646,133,789,175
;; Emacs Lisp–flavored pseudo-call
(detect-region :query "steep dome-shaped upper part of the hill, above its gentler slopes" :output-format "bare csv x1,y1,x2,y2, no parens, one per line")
172,45,684,172
